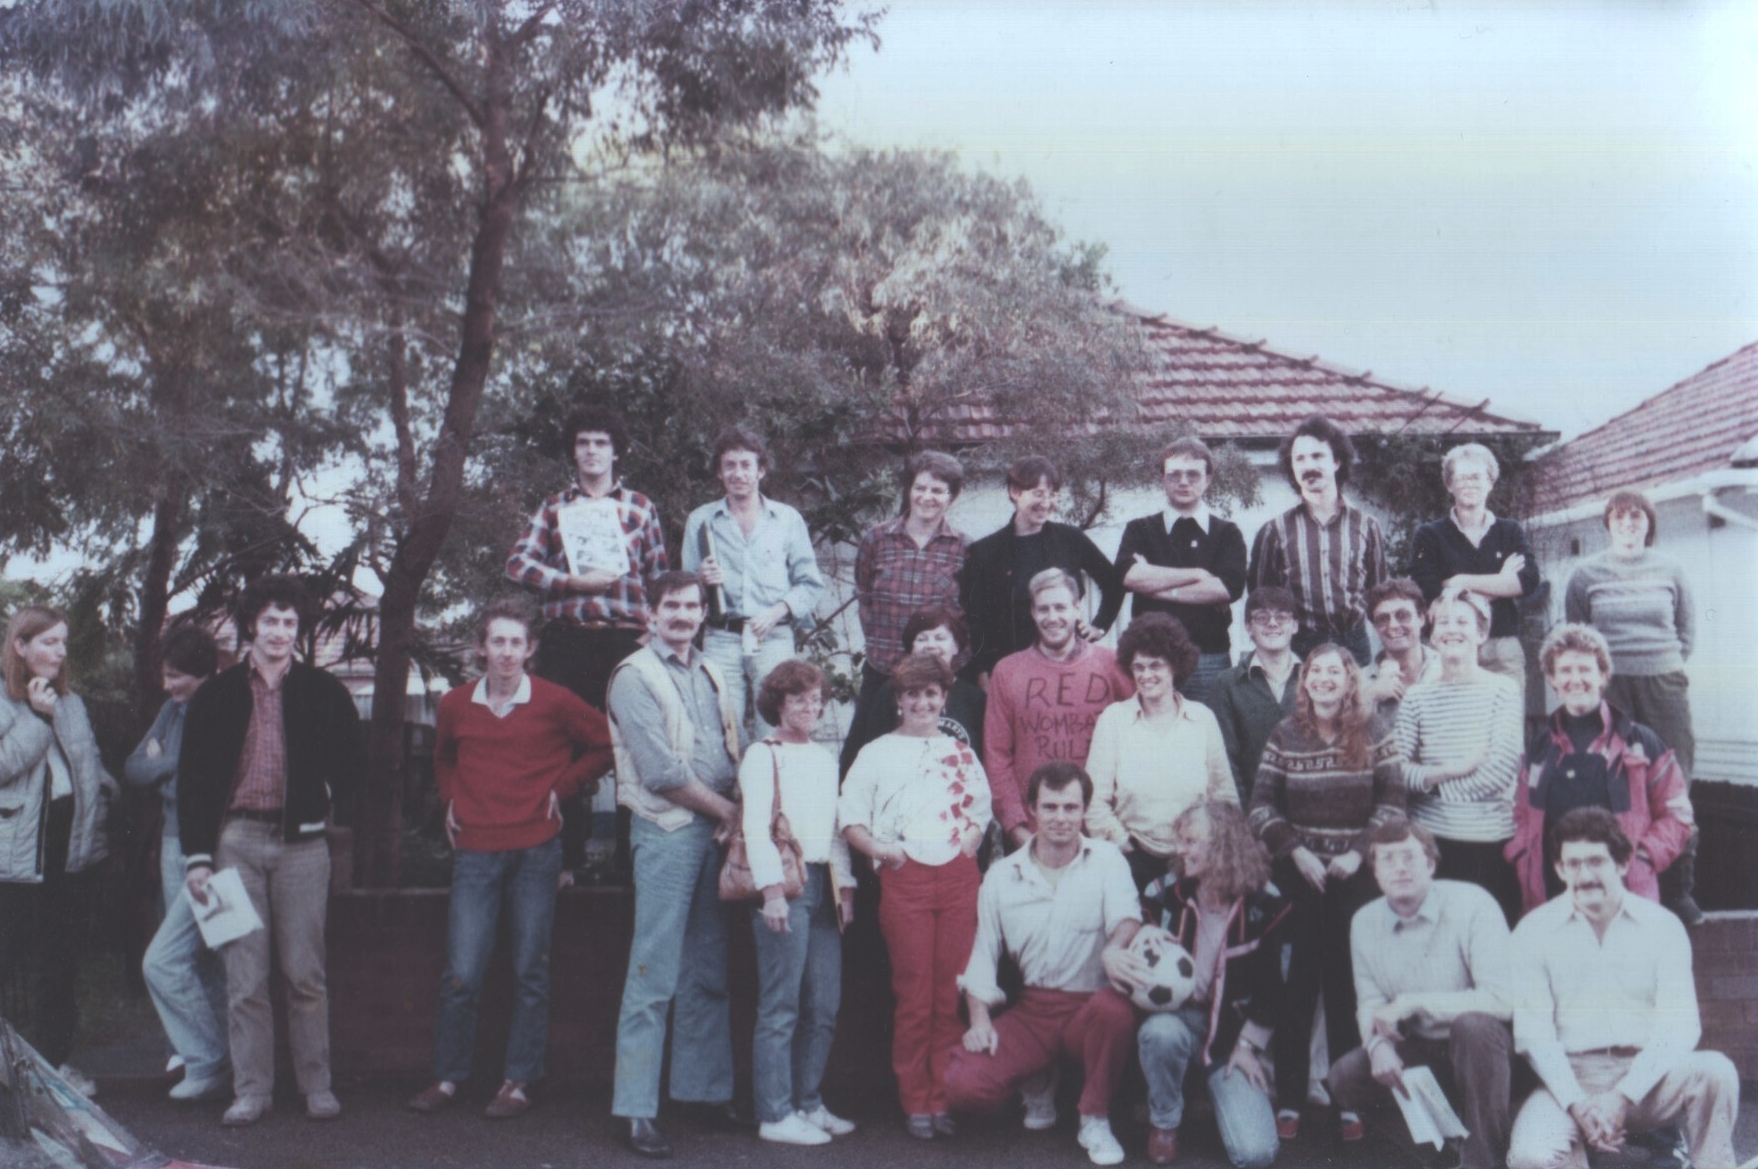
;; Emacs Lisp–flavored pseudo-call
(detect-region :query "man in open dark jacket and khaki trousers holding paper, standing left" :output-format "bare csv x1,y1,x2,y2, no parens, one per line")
178,575,364,1125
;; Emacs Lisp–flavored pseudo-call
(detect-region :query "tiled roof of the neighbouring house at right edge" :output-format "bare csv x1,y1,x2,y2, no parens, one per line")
1545,343,1758,508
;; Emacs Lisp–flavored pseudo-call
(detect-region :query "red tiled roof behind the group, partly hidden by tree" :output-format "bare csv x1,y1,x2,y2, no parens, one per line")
914,302,1542,443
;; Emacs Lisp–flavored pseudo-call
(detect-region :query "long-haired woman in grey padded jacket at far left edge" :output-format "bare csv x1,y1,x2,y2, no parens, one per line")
0,605,118,1095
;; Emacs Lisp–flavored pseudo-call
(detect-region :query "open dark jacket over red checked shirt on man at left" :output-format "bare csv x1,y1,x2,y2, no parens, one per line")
178,659,366,865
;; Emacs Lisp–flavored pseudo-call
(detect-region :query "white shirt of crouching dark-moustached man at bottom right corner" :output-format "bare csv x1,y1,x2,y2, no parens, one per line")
1514,891,1704,1107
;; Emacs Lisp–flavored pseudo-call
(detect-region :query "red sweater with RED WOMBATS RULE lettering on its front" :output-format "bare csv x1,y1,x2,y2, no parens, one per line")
983,642,1136,831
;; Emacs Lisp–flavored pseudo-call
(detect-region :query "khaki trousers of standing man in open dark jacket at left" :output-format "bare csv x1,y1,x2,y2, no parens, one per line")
214,819,331,1097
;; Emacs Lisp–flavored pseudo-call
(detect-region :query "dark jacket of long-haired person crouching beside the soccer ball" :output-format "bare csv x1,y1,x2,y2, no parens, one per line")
1141,877,1292,1067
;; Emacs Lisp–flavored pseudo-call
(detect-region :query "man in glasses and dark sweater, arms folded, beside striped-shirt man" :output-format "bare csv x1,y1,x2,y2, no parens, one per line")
1116,438,1246,701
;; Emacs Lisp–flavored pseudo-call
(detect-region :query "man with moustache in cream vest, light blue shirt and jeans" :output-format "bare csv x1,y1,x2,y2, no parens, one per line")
610,571,740,1157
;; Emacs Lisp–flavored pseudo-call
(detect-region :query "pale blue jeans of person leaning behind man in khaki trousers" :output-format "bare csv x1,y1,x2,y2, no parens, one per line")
141,837,229,1081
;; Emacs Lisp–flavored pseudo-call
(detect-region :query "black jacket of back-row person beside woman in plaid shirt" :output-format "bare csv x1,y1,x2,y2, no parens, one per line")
958,519,1123,680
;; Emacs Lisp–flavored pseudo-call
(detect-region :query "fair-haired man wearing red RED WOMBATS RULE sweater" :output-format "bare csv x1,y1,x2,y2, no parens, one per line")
983,568,1136,851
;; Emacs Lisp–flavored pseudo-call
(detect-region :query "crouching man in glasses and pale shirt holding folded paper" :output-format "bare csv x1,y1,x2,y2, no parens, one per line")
1326,819,1514,1169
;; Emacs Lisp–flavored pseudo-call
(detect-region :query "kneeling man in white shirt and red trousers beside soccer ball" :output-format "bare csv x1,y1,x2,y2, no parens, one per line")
946,763,1141,1165
